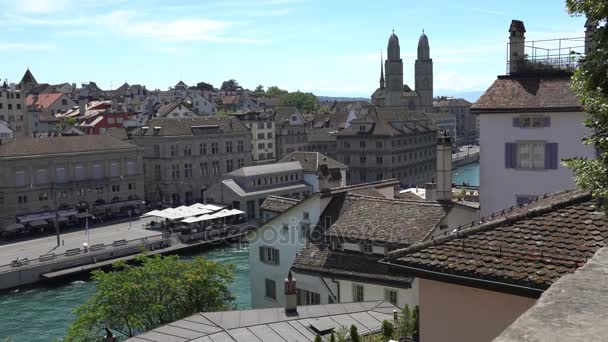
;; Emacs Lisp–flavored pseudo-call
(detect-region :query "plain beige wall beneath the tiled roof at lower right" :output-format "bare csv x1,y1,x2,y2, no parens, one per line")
419,279,536,342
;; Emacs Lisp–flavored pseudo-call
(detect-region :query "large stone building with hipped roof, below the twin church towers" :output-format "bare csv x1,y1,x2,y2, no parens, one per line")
336,106,437,185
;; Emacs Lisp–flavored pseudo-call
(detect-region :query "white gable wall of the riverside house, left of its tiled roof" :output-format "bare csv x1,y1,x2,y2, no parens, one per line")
249,195,330,309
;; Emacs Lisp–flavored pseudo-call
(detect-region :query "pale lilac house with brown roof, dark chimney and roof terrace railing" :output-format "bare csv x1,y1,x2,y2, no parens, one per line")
471,20,595,216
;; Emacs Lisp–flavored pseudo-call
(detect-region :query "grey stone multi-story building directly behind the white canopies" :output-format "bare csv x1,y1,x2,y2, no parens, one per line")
131,116,251,205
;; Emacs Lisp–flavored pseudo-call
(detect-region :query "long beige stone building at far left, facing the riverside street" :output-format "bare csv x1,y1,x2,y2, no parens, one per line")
0,135,144,230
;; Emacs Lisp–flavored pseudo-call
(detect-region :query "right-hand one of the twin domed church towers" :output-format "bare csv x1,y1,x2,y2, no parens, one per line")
414,30,433,112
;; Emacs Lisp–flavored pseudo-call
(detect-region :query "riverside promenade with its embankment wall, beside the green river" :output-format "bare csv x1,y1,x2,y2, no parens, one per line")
0,218,256,290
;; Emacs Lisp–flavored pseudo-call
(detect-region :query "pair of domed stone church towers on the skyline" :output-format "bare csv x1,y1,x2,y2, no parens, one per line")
372,31,433,112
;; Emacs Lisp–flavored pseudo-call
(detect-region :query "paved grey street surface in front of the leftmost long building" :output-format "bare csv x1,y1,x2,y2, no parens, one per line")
0,218,160,265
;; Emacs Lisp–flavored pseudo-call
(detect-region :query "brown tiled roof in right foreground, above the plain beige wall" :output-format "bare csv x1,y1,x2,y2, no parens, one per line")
388,191,608,291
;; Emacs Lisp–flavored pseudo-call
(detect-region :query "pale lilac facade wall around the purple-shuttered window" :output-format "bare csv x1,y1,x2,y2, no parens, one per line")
479,112,595,216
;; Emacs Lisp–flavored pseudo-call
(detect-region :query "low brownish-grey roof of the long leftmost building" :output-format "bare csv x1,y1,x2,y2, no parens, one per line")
0,135,138,158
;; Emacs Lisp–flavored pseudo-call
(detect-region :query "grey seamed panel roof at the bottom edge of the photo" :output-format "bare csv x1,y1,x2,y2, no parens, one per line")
127,301,397,342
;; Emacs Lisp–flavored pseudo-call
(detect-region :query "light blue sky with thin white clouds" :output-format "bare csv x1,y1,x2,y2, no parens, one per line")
0,0,584,97
